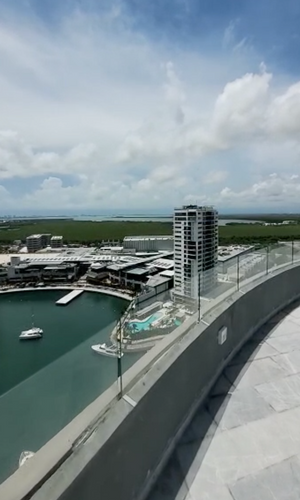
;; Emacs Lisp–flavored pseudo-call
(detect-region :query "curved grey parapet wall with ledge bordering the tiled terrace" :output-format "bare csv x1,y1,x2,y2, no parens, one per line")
0,266,300,500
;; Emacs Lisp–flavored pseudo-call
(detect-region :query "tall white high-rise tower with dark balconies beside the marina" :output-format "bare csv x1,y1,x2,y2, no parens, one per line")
174,205,218,303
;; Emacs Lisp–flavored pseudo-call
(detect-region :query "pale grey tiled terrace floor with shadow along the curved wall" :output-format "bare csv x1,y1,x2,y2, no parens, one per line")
149,298,300,500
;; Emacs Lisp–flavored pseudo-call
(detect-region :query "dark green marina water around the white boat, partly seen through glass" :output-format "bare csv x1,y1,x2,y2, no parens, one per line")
0,290,141,482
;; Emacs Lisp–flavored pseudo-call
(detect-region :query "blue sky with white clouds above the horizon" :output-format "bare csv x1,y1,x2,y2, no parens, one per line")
0,0,300,214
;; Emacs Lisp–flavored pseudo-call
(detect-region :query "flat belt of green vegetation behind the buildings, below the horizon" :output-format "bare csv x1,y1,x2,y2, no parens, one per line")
0,217,300,247
